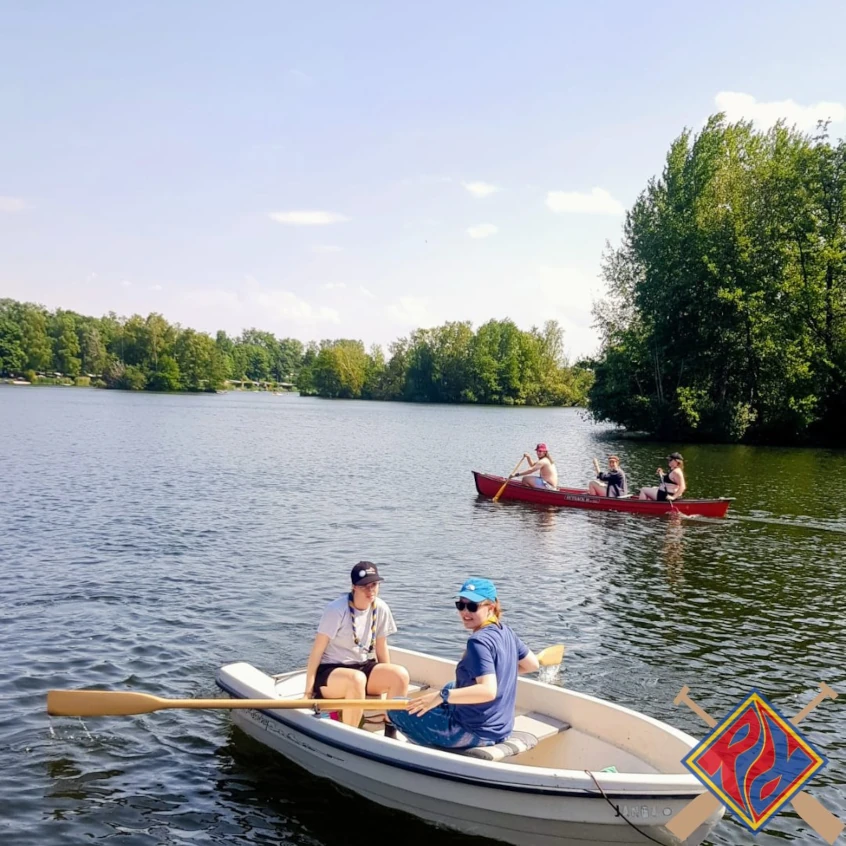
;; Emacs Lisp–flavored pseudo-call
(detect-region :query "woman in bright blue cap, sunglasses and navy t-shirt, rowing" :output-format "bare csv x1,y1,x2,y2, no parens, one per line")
388,578,539,749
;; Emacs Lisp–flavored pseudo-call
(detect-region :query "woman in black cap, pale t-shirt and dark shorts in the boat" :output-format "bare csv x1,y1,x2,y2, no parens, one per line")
305,561,408,726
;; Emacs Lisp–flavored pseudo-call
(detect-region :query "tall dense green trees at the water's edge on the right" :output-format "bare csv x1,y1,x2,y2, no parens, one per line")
589,115,846,443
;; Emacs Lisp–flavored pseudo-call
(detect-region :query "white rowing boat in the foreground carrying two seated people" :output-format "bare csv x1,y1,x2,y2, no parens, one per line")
217,647,725,846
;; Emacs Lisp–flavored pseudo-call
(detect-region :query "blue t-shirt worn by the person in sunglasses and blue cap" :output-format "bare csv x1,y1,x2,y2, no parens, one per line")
453,623,529,743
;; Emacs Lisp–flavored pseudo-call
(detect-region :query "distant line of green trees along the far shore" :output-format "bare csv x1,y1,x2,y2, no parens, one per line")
0,300,592,405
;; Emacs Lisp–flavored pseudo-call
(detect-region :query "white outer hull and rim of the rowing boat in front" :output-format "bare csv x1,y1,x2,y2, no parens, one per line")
218,648,723,846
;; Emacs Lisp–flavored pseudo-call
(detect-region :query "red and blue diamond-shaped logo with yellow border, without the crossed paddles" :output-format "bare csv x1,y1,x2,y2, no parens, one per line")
682,688,828,833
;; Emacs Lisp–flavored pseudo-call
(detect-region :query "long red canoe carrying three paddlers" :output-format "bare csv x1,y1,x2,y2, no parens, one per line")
473,470,734,517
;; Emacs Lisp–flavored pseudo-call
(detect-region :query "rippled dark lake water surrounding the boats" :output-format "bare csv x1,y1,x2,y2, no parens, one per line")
0,387,846,846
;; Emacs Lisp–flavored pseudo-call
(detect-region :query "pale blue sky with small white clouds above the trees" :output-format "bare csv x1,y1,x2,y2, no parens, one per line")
0,0,846,357
